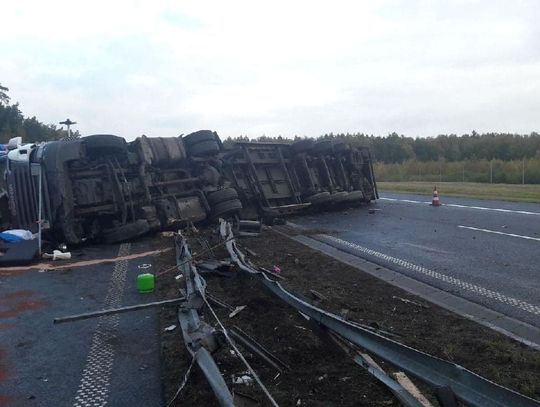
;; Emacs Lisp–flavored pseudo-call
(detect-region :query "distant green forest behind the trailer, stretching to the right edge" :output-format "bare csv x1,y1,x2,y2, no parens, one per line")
227,131,540,164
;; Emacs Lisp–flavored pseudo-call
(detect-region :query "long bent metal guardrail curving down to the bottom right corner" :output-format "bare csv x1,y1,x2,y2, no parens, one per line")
220,219,540,407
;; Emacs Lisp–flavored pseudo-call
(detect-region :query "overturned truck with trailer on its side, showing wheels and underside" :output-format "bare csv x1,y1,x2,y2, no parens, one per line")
0,130,378,244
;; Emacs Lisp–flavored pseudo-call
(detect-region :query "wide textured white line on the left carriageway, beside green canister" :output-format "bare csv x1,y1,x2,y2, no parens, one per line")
73,243,130,407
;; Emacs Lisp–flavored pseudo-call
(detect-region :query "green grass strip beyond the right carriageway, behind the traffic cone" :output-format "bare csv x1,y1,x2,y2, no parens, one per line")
377,182,540,203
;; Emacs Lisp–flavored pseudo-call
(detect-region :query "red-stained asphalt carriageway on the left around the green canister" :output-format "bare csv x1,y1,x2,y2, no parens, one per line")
0,241,162,407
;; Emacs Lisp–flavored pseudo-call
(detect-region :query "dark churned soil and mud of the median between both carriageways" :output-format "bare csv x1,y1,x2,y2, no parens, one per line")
155,228,540,406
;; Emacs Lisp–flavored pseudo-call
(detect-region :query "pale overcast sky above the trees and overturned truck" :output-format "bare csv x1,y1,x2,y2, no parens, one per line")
0,0,540,139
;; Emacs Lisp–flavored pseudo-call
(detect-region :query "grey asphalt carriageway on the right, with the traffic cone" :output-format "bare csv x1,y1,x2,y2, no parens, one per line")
291,193,540,327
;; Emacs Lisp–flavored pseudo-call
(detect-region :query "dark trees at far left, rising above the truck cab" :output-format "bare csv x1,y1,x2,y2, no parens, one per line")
0,83,67,144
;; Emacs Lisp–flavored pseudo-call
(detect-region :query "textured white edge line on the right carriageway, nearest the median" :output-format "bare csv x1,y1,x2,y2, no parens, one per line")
318,235,540,315
